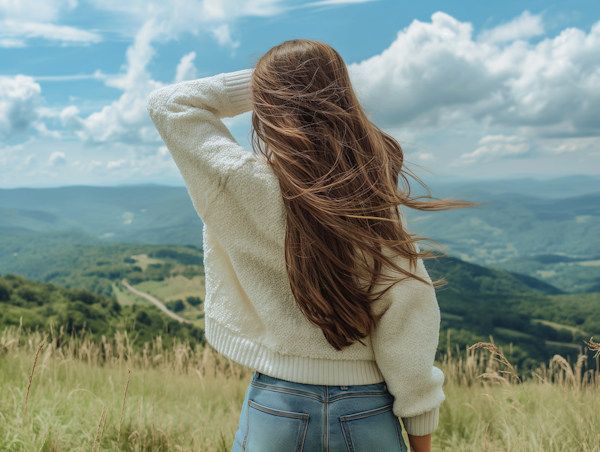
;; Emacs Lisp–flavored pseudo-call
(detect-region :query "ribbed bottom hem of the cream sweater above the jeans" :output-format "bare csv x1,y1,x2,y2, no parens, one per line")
205,318,384,386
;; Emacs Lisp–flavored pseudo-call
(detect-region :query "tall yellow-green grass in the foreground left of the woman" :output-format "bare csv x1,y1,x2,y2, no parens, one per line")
0,328,252,451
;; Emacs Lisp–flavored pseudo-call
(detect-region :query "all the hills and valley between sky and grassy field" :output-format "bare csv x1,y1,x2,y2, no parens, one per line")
0,177,600,371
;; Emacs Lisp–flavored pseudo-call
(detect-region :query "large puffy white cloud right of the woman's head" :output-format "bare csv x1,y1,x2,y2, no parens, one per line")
349,12,600,136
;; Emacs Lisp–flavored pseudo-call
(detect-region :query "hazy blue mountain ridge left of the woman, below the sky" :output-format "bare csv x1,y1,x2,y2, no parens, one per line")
0,185,202,246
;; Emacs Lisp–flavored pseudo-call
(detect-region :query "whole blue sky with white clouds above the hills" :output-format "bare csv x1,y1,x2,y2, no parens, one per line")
0,0,600,188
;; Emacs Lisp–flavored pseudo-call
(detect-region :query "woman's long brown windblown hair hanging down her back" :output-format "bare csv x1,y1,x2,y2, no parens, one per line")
251,39,477,350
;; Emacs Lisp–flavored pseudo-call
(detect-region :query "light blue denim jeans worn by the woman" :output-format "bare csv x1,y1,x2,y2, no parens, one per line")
231,372,408,452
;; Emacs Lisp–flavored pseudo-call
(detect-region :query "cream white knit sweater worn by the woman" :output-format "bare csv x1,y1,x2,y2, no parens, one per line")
147,69,445,436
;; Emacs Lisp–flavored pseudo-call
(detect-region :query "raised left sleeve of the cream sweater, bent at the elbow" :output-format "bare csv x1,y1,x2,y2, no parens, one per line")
146,69,254,224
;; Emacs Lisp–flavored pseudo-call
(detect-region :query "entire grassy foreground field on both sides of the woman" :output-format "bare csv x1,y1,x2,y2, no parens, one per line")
0,328,600,452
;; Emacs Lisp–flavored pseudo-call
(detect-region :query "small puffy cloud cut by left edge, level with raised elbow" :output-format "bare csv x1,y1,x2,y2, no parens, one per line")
0,75,42,138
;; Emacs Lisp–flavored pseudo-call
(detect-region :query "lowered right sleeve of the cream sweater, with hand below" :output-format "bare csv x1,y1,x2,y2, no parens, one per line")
371,254,446,436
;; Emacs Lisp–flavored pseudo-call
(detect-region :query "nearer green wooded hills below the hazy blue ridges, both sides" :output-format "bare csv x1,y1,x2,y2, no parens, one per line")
0,237,600,369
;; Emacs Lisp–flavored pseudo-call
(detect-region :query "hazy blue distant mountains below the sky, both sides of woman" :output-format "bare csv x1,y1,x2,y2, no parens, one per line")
0,176,600,293
